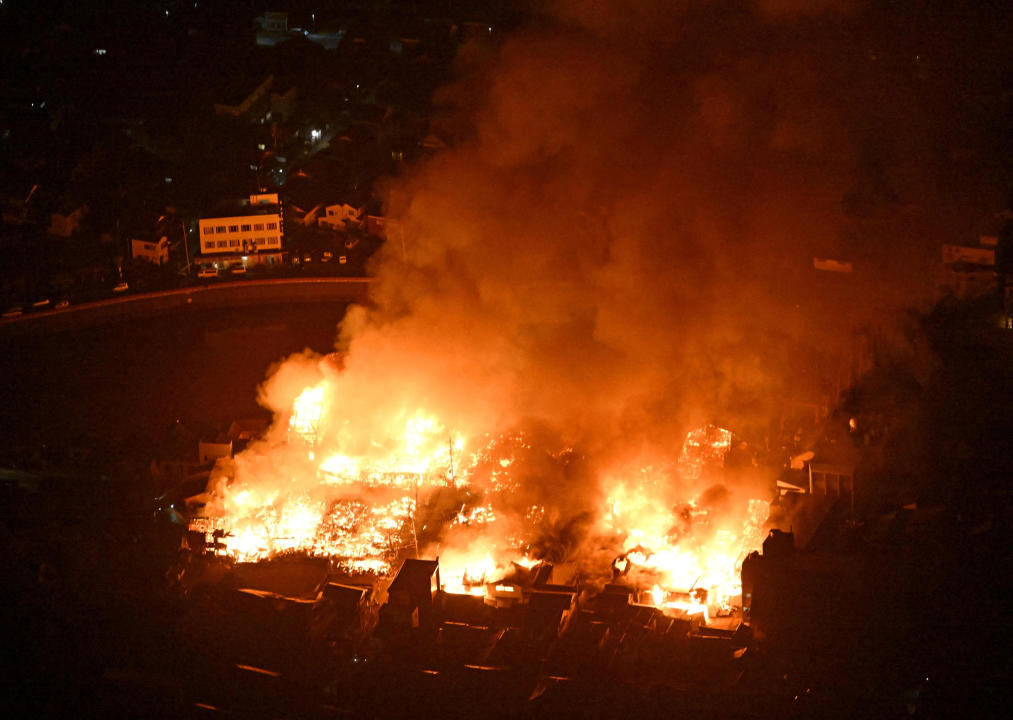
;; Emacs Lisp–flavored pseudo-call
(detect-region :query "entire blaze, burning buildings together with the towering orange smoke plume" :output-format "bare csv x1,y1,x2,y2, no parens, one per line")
172,3,948,696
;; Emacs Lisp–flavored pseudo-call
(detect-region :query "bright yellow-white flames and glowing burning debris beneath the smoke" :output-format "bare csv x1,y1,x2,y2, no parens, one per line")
184,368,768,622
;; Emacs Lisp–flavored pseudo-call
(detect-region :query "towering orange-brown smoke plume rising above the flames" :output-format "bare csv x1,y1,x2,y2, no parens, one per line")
340,0,923,447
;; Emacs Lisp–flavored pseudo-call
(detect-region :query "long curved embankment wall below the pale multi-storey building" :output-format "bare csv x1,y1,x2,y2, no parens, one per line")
0,277,373,333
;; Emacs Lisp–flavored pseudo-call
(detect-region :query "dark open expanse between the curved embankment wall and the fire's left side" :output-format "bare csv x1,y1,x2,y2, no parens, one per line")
0,303,346,455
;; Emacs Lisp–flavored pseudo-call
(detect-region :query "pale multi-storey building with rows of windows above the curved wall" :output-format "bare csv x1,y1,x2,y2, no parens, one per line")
198,193,285,264
